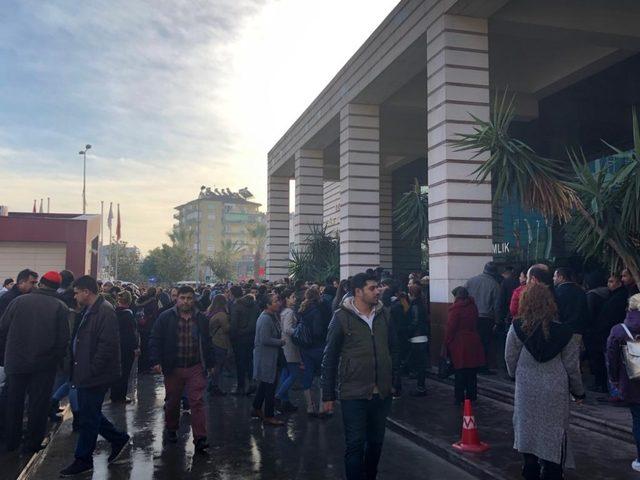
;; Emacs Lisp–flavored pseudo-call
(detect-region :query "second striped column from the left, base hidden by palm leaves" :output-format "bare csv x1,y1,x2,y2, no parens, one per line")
293,150,324,249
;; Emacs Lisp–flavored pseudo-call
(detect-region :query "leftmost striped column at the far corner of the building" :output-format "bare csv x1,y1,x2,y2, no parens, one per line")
266,176,289,280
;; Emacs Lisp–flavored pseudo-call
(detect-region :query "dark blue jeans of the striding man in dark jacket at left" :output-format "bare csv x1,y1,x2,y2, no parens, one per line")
75,387,129,463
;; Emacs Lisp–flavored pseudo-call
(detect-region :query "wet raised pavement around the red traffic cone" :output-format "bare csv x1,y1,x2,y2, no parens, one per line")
391,380,640,480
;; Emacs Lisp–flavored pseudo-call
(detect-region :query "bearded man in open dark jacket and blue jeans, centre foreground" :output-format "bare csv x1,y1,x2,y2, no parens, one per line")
322,273,398,480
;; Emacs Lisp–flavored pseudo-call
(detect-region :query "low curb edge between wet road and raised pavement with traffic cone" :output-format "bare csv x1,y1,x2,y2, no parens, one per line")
387,417,509,480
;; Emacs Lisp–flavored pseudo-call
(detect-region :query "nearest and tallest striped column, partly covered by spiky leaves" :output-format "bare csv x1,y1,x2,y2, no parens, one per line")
427,15,492,351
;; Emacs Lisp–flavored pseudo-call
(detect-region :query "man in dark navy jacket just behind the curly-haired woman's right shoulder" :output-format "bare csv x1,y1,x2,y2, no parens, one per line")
553,267,589,335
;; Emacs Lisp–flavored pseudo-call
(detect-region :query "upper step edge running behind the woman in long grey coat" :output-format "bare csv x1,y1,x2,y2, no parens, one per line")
427,371,635,445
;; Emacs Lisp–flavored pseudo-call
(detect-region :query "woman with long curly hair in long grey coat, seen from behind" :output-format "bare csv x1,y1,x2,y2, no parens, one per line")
505,284,585,480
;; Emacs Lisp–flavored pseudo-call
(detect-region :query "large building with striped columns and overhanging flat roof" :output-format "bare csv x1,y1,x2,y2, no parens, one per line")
267,0,640,356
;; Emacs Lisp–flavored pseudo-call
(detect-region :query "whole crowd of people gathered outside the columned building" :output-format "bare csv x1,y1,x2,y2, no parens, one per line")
0,262,640,480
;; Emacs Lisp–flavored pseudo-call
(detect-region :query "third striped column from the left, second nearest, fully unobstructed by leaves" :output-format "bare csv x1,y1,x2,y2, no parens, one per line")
340,104,380,278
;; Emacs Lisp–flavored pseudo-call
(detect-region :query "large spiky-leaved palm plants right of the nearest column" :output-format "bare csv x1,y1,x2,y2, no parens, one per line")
452,93,640,284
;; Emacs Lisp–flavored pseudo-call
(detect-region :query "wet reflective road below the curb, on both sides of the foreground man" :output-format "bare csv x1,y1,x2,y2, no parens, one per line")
31,376,475,480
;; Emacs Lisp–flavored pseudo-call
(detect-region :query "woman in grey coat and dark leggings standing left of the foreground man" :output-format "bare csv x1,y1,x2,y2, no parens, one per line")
251,293,285,426
